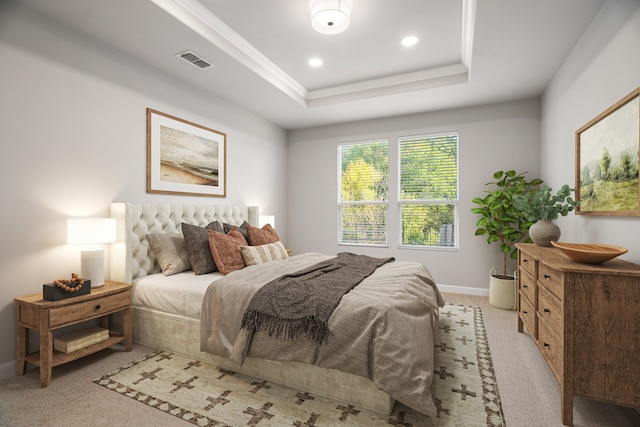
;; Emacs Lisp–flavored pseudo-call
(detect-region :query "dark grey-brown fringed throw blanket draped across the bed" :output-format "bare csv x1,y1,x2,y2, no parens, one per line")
242,252,394,344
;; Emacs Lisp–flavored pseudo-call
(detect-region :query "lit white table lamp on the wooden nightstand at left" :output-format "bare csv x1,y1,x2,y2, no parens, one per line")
67,218,116,288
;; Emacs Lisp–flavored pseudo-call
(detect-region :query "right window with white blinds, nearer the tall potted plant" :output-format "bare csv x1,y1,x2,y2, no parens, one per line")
398,134,458,247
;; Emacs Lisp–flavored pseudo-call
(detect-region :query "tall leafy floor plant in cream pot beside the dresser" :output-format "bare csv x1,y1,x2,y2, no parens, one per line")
471,170,543,309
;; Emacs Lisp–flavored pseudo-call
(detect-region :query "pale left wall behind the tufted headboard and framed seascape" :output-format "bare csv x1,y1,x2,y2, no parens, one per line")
0,6,286,377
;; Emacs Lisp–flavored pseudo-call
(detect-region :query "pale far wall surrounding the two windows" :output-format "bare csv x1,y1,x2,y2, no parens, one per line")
287,99,540,293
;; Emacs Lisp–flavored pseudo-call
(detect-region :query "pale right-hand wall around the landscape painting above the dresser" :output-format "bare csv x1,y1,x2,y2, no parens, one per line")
540,0,640,262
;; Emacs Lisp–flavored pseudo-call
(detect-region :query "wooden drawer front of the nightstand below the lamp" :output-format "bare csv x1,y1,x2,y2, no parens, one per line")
49,292,131,328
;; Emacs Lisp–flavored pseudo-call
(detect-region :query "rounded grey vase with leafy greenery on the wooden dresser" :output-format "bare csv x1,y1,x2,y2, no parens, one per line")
513,184,578,246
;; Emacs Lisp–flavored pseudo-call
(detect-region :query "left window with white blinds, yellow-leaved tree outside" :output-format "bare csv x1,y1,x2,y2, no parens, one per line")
338,140,389,246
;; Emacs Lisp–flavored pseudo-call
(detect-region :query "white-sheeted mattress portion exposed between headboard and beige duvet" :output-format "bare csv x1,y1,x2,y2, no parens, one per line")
133,271,224,322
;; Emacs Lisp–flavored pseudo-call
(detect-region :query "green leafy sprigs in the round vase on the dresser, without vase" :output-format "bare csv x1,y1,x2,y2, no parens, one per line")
513,184,578,222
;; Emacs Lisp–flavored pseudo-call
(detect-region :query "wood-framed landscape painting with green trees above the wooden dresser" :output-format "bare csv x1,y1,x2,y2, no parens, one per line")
575,87,640,216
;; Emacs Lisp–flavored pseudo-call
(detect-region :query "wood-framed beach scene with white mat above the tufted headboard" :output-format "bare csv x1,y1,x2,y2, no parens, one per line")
147,108,227,197
